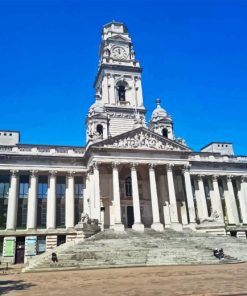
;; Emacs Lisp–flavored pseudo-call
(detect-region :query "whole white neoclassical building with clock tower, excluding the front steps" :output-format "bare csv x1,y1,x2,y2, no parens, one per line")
0,22,247,262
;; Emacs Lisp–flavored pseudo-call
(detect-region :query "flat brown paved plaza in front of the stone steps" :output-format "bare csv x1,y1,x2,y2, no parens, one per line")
0,263,247,296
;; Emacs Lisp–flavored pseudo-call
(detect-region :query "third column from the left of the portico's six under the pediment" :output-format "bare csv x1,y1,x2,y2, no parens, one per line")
131,164,144,231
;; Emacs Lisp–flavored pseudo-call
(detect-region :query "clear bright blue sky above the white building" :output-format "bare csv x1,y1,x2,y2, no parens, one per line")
0,0,247,155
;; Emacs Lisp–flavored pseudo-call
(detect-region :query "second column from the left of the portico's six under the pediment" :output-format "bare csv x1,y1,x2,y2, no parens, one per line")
112,163,124,231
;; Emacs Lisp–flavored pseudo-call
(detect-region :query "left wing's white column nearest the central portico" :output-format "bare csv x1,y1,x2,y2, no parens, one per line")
65,172,75,229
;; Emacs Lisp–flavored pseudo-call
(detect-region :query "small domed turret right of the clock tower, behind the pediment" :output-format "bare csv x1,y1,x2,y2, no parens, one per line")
148,99,174,140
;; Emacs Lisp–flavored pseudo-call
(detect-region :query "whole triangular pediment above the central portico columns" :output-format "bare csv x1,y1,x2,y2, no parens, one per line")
93,127,191,151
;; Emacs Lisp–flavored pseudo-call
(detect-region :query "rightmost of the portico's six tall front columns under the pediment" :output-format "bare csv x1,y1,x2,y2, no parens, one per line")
183,165,196,227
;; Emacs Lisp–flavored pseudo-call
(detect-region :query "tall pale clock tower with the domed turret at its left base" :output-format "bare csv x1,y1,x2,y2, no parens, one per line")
87,21,146,141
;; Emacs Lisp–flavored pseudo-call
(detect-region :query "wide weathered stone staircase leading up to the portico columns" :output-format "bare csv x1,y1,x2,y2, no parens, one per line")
24,229,247,271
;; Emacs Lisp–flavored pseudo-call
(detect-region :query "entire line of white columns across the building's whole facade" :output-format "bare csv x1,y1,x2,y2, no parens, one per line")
3,162,247,230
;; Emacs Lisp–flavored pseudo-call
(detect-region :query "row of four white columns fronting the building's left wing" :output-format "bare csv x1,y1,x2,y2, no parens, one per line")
6,171,79,230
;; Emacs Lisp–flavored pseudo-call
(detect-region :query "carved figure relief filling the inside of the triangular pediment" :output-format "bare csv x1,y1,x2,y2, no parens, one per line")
103,131,182,151
